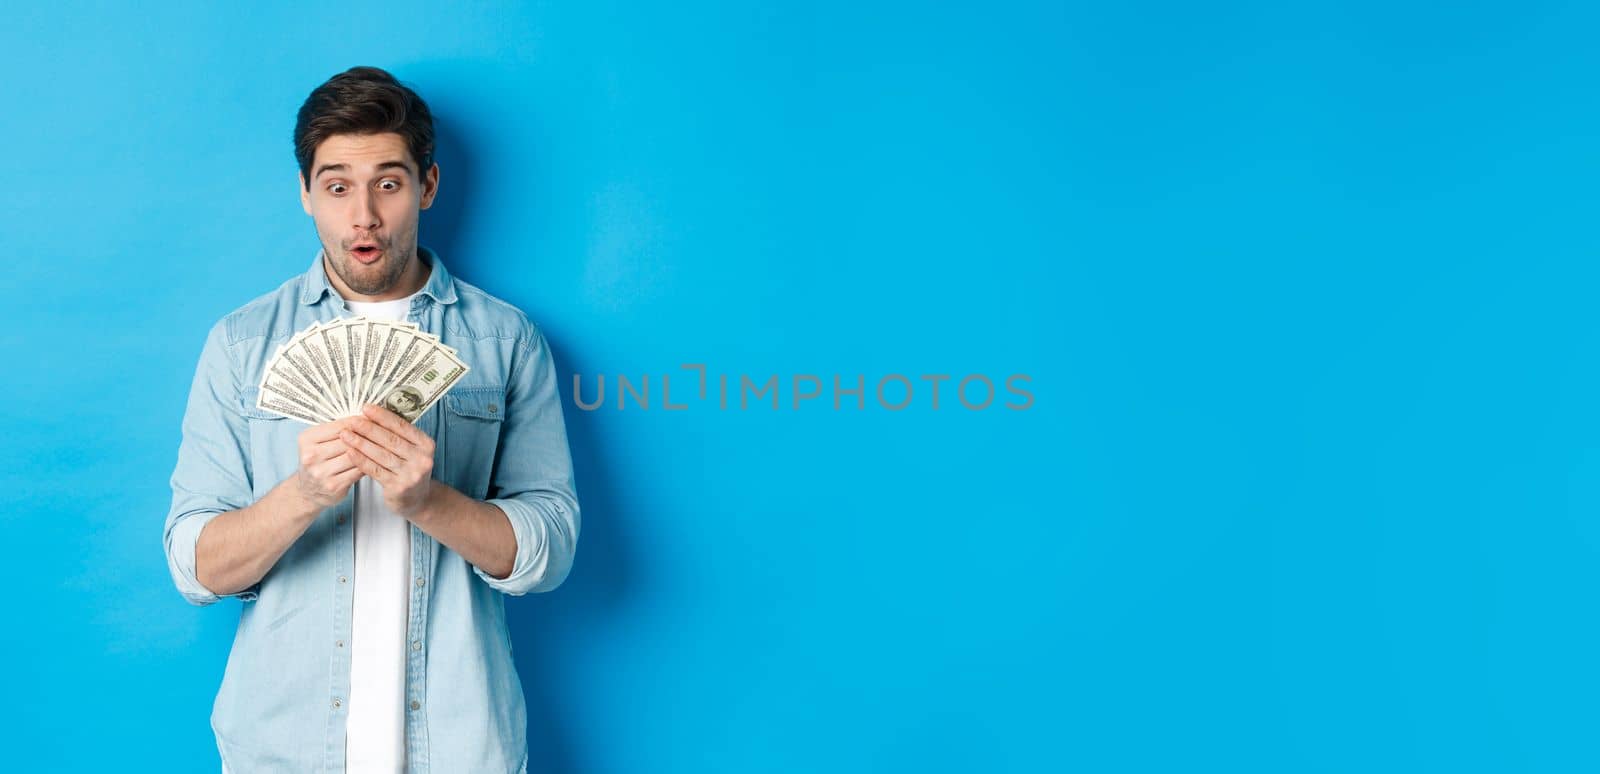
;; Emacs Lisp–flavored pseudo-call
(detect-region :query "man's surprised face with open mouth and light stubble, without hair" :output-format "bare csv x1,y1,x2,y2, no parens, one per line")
299,133,438,301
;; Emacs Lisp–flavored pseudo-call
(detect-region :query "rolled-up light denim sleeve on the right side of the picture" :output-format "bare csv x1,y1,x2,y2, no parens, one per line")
472,323,581,596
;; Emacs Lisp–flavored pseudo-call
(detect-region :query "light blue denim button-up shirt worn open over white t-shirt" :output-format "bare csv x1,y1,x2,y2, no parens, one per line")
162,248,579,774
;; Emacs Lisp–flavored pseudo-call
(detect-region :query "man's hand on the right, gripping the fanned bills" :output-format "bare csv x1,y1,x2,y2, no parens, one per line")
339,403,434,520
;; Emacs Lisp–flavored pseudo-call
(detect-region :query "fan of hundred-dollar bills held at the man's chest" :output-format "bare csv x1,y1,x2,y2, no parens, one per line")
256,317,467,424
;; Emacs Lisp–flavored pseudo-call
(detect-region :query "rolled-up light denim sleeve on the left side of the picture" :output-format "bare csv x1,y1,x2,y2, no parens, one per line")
162,320,261,604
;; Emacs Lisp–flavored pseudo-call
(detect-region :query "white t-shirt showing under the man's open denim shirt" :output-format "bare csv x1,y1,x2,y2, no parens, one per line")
344,296,414,774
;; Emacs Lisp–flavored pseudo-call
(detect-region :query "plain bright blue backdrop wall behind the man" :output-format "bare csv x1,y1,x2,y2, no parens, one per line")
0,2,1600,772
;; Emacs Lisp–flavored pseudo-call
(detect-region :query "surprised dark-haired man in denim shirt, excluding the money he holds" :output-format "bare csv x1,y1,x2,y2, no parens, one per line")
163,67,579,774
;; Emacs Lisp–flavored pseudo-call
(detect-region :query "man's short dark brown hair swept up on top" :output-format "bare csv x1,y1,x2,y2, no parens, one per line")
294,67,434,190
